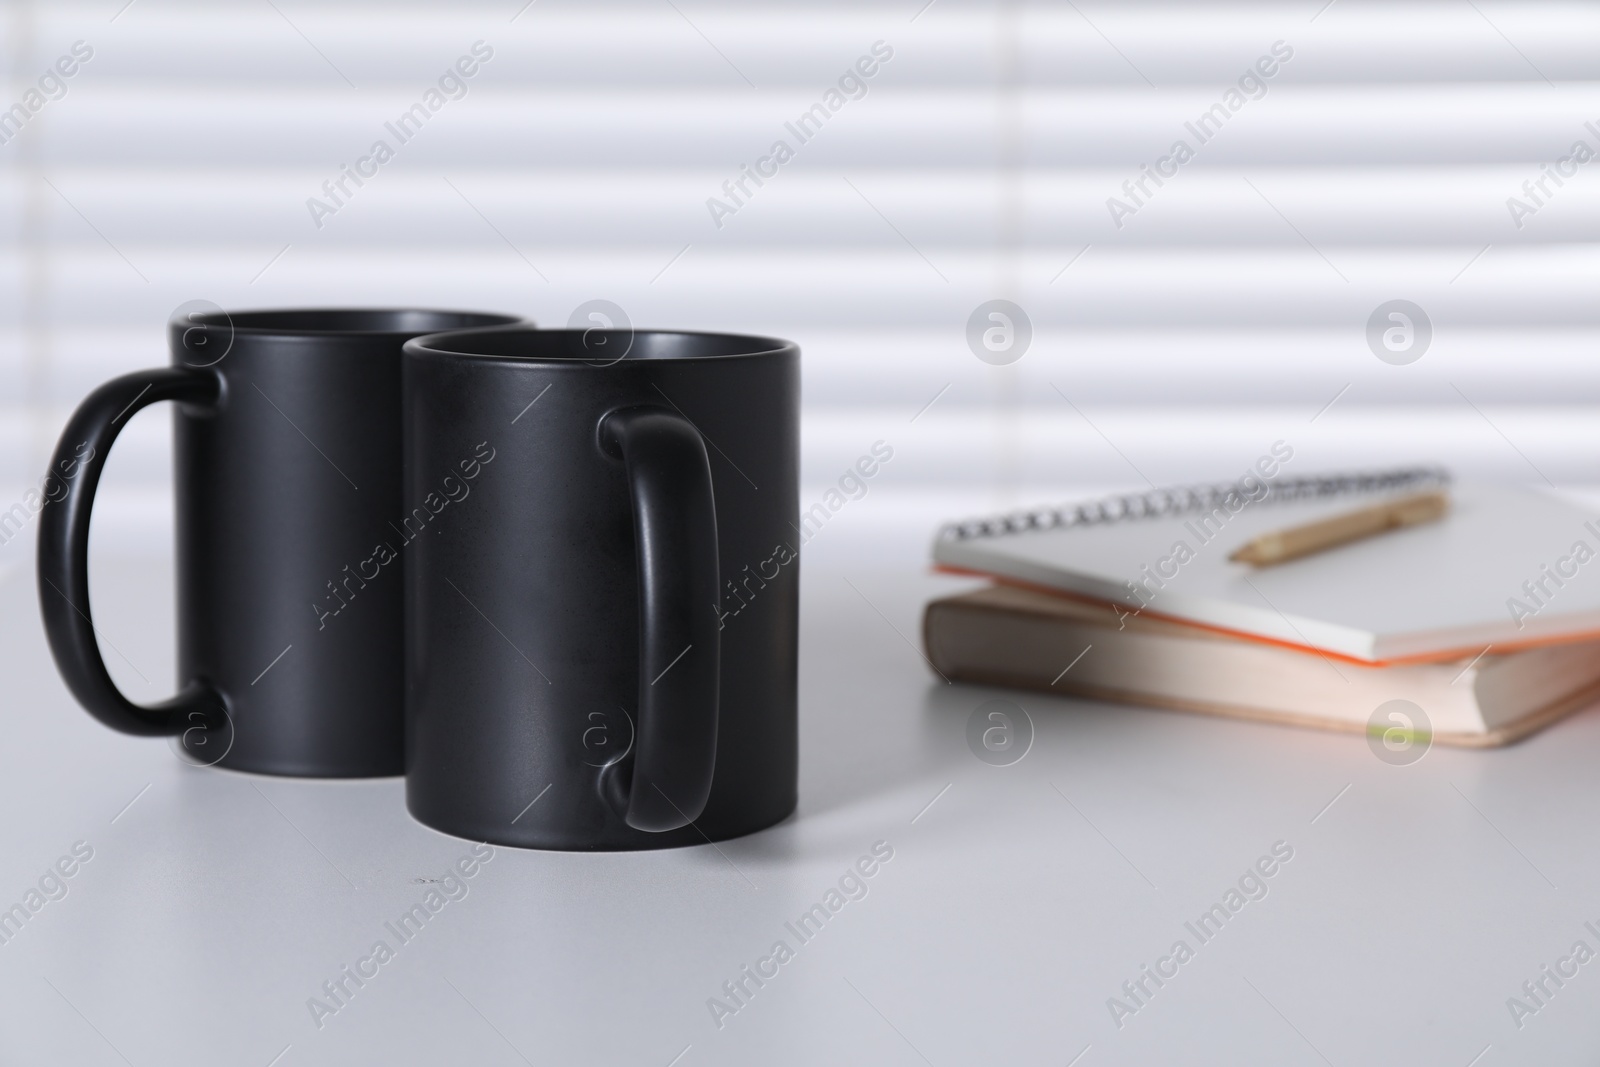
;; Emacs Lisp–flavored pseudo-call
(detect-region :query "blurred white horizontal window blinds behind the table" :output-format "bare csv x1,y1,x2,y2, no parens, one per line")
0,0,1600,568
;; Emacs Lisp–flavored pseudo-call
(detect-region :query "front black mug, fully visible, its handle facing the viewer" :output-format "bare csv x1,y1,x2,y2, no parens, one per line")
403,328,800,851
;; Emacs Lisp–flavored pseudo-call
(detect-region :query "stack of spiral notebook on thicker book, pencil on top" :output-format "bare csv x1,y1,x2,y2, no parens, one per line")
923,469,1600,745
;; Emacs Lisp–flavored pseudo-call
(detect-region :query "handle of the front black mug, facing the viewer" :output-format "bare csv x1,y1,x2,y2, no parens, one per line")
600,408,722,833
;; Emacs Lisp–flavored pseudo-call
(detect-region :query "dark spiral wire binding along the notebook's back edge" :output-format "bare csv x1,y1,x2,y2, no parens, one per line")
939,467,1451,541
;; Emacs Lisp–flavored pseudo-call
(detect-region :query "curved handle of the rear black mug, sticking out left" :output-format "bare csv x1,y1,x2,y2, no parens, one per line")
38,366,226,737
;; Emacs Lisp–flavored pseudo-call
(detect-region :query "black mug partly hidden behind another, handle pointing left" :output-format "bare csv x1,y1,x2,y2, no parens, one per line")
38,309,520,777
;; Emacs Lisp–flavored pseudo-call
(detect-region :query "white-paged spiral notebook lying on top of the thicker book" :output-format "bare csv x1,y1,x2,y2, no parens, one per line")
933,467,1600,664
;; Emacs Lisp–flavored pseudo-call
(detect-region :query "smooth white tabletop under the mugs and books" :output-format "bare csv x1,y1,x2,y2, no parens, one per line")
0,543,1600,1067
